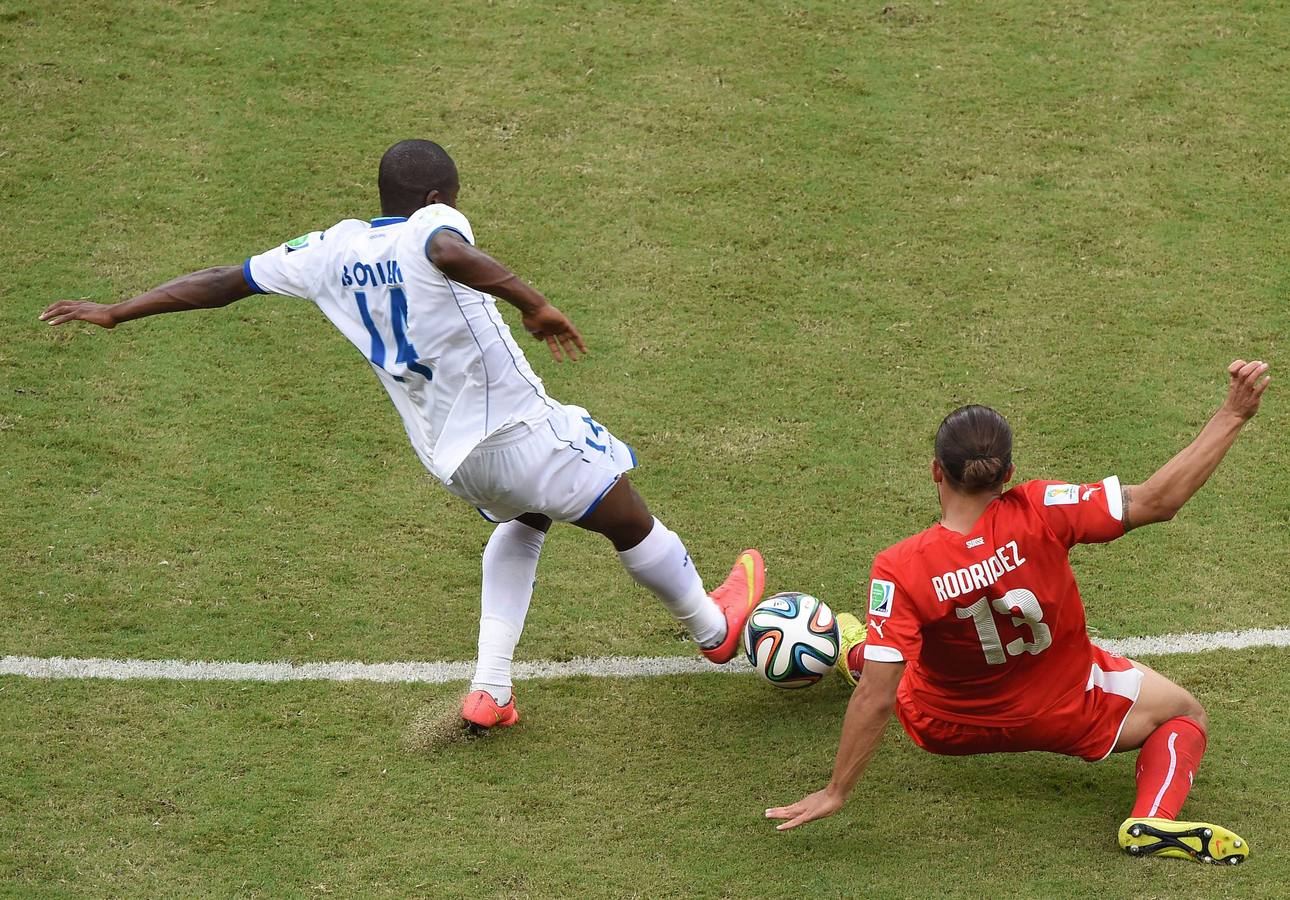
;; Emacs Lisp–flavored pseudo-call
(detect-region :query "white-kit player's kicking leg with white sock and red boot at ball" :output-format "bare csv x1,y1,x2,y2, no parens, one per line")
574,476,766,663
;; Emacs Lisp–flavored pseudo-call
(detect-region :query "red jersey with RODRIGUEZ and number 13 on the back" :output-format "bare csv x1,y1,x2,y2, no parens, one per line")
864,476,1125,726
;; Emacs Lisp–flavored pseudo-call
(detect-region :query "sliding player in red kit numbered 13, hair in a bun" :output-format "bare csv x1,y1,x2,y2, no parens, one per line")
766,360,1269,864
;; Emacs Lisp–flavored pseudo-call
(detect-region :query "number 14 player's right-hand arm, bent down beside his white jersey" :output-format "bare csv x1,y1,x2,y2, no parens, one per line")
426,228,587,362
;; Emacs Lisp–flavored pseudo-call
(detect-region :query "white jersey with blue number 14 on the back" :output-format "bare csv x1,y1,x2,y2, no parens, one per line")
243,204,555,484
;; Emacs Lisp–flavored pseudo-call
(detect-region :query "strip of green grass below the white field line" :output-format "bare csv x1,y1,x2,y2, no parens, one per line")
0,651,1290,897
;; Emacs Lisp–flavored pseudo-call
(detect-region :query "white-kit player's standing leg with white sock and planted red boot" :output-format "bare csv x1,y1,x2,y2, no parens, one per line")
462,513,551,729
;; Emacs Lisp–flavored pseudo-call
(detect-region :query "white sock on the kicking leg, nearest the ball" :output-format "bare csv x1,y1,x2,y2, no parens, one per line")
618,518,726,647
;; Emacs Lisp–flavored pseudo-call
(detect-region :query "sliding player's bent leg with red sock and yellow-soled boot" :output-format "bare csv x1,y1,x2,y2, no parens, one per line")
1115,661,1250,865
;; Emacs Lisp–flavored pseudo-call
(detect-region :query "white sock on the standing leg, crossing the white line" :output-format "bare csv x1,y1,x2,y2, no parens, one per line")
471,521,547,705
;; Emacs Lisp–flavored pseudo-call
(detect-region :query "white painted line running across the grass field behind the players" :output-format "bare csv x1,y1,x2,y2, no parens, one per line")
0,628,1290,685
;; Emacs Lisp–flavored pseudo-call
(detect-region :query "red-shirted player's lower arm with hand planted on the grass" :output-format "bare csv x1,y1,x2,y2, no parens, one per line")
766,659,904,832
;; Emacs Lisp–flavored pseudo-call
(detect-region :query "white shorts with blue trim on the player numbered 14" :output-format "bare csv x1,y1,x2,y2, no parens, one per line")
445,405,636,522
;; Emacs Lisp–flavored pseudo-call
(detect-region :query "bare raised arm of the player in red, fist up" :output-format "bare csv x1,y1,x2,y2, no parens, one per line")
1124,360,1272,531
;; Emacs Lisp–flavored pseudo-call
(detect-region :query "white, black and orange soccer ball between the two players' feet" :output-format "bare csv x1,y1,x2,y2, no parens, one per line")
743,592,841,687
